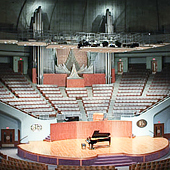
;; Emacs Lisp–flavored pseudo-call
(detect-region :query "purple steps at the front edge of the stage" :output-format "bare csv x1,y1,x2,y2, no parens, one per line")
92,155,136,167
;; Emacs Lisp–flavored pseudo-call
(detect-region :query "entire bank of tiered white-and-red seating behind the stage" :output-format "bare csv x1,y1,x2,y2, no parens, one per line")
0,63,170,120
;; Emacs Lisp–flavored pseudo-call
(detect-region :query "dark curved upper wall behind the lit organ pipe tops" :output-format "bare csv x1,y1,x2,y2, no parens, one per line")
0,0,170,32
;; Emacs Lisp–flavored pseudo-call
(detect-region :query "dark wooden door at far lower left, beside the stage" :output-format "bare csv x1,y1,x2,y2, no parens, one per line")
1,129,15,147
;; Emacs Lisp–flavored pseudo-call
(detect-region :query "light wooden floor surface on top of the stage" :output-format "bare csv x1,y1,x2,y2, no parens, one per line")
19,136,169,159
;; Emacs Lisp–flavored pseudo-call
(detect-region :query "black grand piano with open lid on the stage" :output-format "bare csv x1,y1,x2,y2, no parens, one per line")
86,130,111,149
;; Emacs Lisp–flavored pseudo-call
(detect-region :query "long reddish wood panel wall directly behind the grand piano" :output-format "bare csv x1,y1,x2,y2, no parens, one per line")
50,120,132,141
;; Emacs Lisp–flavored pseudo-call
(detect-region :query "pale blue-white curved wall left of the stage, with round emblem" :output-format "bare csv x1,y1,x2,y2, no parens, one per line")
0,102,57,143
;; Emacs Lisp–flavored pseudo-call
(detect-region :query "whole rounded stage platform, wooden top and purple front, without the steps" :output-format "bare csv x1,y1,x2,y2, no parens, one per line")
18,136,169,165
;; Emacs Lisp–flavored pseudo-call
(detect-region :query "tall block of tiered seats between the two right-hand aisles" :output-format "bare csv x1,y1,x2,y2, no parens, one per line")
112,67,150,117
